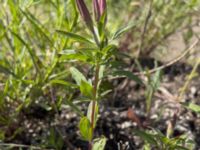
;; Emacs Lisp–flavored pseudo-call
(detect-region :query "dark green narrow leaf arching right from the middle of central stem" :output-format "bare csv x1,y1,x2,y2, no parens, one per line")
112,71,143,84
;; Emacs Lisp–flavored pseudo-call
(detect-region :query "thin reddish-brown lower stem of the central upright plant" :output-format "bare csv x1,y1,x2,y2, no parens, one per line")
89,64,100,150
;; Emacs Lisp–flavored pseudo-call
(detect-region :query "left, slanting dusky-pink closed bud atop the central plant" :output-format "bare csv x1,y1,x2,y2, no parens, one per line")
76,0,94,33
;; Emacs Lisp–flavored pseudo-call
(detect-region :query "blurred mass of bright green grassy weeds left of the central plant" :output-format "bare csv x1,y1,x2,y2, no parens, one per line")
0,0,81,147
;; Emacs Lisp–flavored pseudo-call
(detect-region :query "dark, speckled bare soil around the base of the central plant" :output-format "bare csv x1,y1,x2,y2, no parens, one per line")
1,60,200,150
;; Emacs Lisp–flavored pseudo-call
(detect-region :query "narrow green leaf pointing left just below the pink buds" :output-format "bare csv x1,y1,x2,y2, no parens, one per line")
56,30,94,45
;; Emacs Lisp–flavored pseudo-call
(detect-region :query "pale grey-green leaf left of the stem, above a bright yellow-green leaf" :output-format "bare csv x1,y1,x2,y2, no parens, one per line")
70,67,87,85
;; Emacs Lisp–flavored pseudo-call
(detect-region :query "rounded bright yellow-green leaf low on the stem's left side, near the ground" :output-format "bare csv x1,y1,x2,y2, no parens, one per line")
79,117,92,141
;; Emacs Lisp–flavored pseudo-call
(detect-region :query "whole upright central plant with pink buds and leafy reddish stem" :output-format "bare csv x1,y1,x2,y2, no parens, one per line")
57,0,141,150
